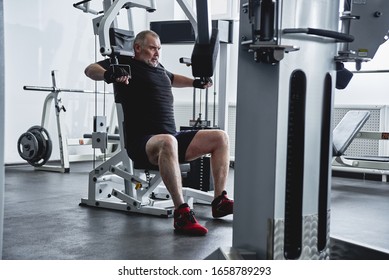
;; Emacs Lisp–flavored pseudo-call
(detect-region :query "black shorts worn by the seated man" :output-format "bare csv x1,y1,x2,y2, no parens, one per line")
126,130,198,169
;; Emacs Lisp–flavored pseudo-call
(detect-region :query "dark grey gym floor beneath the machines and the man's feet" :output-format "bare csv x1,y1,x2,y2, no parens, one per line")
3,162,389,260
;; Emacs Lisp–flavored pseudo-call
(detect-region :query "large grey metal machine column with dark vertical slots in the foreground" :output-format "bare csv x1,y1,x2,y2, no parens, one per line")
233,0,339,259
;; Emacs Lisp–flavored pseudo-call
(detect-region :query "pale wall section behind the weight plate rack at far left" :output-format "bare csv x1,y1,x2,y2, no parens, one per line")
4,0,107,163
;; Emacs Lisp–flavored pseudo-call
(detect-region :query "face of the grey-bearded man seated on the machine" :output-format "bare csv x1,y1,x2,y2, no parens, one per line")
134,35,161,67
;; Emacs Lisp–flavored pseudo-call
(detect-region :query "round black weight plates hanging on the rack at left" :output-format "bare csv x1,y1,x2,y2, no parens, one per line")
18,126,52,167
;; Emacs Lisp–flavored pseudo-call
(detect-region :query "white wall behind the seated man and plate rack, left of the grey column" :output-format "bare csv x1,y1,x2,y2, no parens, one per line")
4,0,237,164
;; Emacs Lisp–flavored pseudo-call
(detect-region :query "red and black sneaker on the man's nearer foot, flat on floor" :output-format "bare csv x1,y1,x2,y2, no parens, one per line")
174,203,208,235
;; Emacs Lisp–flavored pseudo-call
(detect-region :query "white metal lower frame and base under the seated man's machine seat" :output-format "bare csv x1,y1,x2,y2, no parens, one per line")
80,104,213,217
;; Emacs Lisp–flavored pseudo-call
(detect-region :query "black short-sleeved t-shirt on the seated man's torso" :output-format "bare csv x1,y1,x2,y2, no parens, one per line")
98,57,176,143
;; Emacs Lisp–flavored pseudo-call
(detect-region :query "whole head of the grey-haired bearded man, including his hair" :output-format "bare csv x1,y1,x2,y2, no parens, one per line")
134,30,161,67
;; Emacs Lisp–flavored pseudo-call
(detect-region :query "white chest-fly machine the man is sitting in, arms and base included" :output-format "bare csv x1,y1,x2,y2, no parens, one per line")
74,0,218,217
